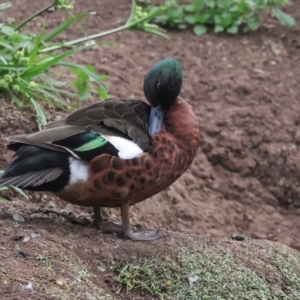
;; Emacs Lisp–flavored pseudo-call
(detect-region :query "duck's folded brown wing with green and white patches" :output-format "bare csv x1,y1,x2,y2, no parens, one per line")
7,99,151,160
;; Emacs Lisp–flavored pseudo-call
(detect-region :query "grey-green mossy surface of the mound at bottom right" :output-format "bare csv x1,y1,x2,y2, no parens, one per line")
116,237,300,300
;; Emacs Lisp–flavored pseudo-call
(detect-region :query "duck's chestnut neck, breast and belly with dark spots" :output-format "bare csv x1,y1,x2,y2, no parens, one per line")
57,97,200,208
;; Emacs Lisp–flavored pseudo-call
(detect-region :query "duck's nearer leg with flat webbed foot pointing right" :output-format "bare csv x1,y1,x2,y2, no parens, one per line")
121,203,159,241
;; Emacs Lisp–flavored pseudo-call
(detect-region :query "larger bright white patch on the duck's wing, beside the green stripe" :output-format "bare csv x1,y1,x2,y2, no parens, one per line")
102,135,144,159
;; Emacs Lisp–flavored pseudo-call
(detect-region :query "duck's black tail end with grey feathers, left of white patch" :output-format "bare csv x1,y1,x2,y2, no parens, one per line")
0,145,70,192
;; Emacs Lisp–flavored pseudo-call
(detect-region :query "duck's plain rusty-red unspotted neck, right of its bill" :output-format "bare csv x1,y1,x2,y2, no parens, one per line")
164,97,200,158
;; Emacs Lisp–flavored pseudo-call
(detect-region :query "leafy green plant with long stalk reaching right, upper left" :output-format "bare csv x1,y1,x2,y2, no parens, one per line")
0,0,164,128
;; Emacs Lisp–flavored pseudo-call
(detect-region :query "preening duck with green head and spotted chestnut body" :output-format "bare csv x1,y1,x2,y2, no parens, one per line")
0,57,200,241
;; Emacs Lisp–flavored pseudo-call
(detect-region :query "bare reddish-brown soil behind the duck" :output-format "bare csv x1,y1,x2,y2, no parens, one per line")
0,0,300,299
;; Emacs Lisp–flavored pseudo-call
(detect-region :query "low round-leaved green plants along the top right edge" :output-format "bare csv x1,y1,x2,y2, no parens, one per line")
139,0,295,35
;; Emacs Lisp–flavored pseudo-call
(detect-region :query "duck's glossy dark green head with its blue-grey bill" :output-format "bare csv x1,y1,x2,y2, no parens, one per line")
144,58,182,136
